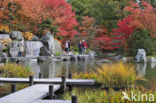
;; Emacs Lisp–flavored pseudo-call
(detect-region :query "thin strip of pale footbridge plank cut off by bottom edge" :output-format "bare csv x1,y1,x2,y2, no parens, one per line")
32,100,71,103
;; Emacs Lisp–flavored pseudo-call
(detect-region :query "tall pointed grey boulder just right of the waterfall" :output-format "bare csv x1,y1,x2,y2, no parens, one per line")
41,32,55,54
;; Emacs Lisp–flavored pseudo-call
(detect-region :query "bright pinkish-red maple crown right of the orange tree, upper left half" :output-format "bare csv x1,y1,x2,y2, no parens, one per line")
44,0,78,37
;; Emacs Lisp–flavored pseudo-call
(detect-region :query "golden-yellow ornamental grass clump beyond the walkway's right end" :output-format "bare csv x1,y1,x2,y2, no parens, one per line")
74,62,145,87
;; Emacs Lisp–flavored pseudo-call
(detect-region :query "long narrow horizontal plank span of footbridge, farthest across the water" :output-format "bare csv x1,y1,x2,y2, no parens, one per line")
0,78,95,85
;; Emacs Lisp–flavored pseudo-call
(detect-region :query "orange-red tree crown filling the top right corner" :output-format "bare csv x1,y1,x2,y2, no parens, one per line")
124,1,156,36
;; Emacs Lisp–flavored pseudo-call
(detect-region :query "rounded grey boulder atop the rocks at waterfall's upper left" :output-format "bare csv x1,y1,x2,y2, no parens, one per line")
10,31,24,40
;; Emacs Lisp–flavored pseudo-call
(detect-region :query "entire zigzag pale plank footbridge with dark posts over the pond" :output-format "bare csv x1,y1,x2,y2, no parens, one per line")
0,76,95,103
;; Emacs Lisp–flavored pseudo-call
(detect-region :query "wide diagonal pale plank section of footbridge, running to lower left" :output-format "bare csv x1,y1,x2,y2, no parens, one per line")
0,84,60,103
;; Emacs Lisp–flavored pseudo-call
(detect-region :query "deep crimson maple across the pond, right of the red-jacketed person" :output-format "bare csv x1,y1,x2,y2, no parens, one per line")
96,16,135,50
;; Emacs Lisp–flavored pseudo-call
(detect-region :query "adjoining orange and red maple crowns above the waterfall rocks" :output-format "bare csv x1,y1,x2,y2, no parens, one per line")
17,0,78,37
